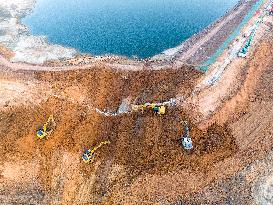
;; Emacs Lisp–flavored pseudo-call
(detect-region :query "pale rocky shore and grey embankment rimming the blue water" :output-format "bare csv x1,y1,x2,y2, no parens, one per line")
0,0,256,67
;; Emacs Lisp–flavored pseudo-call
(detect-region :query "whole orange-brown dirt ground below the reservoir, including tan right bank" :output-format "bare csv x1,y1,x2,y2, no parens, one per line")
0,37,273,204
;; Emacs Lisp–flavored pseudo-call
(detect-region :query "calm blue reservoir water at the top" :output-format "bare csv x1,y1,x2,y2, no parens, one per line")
23,0,238,58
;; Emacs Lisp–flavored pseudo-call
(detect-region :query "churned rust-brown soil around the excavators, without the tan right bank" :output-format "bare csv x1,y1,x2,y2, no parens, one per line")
0,65,236,204
